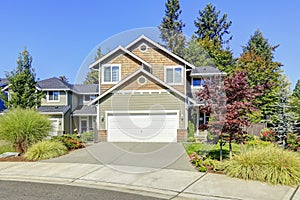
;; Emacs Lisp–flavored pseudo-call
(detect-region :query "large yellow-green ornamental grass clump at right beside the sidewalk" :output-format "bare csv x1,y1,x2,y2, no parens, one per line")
224,146,300,185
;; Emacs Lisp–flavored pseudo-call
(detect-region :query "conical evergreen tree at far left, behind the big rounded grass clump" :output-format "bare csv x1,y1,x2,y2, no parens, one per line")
2,48,44,108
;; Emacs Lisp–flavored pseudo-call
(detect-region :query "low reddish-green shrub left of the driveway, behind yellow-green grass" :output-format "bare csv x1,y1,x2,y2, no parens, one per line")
51,134,84,150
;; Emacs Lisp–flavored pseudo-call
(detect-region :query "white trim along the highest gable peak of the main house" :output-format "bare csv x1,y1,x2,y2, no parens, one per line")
125,35,195,69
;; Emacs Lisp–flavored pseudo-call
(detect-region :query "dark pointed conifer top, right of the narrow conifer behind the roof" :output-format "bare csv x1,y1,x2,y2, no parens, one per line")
194,3,232,45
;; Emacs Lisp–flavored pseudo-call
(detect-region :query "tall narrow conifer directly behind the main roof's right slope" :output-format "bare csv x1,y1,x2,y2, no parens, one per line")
158,0,185,56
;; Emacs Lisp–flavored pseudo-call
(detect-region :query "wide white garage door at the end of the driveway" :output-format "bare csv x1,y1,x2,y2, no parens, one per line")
107,112,178,142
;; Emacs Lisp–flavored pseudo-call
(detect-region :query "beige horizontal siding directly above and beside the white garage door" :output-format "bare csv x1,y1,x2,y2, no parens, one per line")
99,92,185,130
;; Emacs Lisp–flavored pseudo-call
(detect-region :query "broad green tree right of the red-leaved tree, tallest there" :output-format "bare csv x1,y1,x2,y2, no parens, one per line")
238,30,282,121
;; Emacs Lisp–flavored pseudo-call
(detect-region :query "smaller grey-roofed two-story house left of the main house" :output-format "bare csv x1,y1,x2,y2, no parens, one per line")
38,77,98,136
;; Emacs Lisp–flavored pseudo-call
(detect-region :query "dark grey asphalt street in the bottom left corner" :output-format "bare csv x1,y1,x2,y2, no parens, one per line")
0,181,162,200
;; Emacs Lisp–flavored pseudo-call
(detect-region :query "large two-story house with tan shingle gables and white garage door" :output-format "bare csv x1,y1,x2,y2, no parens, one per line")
88,36,224,142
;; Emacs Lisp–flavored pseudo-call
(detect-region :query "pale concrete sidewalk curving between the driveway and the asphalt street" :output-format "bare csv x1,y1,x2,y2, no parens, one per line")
0,162,300,200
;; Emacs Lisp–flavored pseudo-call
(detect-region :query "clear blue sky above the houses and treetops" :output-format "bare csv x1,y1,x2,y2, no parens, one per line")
0,0,300,88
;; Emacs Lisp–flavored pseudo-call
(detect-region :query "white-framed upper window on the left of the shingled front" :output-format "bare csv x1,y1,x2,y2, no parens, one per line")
102,64,121,83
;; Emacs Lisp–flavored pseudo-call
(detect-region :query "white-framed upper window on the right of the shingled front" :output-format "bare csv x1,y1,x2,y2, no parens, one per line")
165,66,183,85
